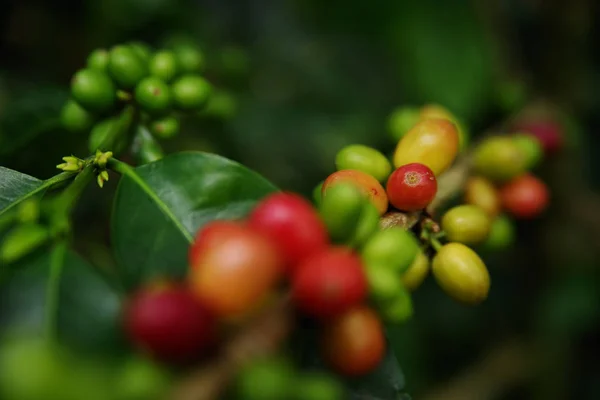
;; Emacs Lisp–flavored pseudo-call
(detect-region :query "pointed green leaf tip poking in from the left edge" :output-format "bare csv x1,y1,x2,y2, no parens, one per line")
0,167,44,215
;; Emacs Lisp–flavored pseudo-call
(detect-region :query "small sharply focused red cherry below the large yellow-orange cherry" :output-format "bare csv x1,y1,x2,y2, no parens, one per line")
386,163,437,211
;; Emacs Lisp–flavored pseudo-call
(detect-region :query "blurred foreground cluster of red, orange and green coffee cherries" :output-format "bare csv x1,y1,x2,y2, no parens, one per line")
124,189,412,376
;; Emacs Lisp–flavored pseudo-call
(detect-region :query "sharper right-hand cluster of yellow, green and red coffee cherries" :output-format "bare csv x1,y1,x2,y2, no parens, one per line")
314,104,561,306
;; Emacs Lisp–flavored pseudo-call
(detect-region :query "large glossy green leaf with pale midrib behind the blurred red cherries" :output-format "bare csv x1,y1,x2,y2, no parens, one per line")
112,152,277,289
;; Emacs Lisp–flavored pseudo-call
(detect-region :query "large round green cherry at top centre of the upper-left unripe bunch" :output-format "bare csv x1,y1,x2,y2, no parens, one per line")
108,45,148,90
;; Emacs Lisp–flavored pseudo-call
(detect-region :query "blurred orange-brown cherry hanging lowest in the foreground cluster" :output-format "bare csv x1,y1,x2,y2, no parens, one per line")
321,305,386,376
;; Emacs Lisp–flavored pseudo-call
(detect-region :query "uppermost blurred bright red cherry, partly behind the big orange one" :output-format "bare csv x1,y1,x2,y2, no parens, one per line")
248,193,329,268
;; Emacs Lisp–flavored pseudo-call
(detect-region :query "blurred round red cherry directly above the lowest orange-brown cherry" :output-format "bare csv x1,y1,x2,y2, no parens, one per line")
292,246,367,318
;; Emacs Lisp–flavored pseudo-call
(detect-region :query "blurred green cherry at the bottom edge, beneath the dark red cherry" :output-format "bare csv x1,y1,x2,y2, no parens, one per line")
115,358,170,400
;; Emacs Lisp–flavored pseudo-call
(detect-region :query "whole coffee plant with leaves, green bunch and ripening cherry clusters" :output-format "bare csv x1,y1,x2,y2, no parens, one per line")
0,34,580,400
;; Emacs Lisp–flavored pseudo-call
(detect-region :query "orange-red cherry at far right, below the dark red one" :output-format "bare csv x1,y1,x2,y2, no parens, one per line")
500,174,550,219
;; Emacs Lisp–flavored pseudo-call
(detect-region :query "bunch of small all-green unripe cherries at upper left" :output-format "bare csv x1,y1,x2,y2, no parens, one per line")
61,42,211,151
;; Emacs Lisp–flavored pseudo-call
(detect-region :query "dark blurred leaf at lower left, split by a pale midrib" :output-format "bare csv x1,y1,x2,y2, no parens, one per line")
0,250,122,351
